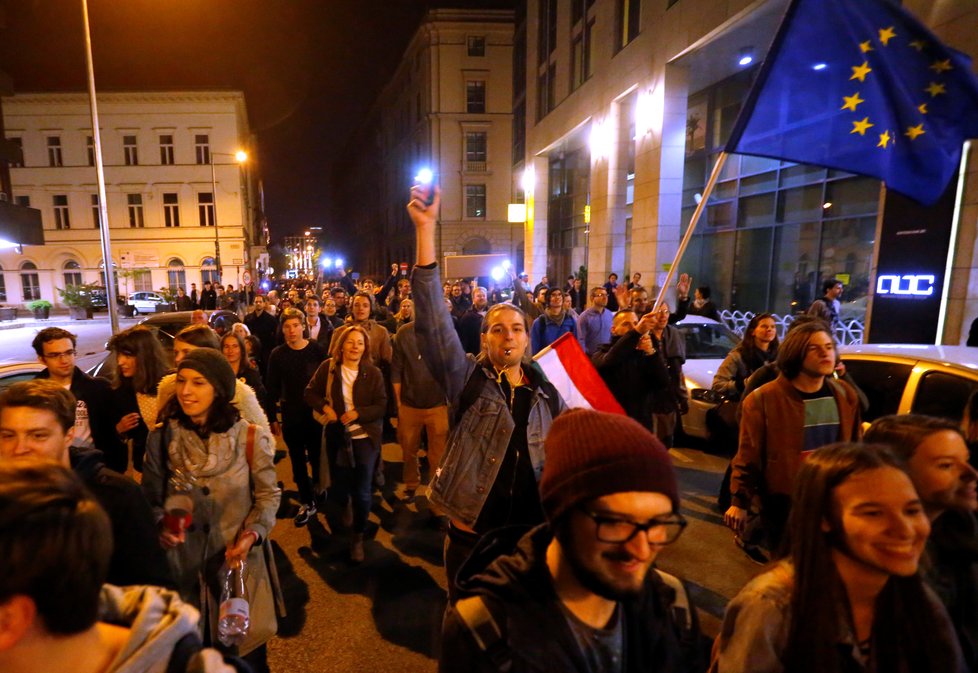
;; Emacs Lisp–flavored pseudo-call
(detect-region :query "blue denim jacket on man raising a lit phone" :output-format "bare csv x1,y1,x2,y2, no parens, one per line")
411,267,564,526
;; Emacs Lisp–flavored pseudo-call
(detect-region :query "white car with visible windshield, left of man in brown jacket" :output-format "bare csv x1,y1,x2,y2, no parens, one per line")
676,315,740,439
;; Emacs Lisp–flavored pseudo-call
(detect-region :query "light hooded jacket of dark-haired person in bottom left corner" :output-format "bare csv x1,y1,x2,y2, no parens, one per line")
98,584,235,673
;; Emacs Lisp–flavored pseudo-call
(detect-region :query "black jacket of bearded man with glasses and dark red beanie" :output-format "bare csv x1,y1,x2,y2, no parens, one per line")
438,525,706,673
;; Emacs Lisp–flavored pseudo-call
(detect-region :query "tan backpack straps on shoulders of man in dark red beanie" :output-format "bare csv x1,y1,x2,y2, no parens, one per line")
455,568,699,673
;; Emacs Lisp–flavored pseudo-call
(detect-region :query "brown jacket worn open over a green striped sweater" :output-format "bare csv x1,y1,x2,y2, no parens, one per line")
730,375,863,509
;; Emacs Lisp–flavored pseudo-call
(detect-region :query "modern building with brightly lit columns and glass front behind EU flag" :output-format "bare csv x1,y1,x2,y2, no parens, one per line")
524,0,978,343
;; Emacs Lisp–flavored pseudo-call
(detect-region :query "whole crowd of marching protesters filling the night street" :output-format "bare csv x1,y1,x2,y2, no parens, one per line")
0,186,978,673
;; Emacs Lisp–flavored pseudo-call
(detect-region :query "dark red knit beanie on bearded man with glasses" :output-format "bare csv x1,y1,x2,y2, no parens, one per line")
540,409,679,522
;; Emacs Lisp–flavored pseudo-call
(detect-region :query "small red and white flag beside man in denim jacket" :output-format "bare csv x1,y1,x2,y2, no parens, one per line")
533,332,625,416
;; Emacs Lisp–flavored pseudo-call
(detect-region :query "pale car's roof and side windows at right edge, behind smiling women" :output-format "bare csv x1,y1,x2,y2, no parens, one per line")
841,344,978,423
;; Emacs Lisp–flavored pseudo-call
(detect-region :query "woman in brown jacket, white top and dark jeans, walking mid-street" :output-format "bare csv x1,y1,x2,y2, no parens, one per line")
304,325,387,563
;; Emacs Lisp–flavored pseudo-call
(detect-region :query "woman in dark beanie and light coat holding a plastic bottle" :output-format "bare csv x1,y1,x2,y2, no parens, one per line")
142,348,281,671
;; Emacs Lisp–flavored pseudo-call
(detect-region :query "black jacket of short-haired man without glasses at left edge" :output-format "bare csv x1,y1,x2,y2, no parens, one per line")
71,447,173,587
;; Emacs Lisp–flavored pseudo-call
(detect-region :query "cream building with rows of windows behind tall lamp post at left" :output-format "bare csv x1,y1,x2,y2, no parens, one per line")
0,91,267,305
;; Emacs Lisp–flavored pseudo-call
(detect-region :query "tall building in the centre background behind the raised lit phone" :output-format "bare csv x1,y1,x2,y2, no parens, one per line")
336,9,523,274
